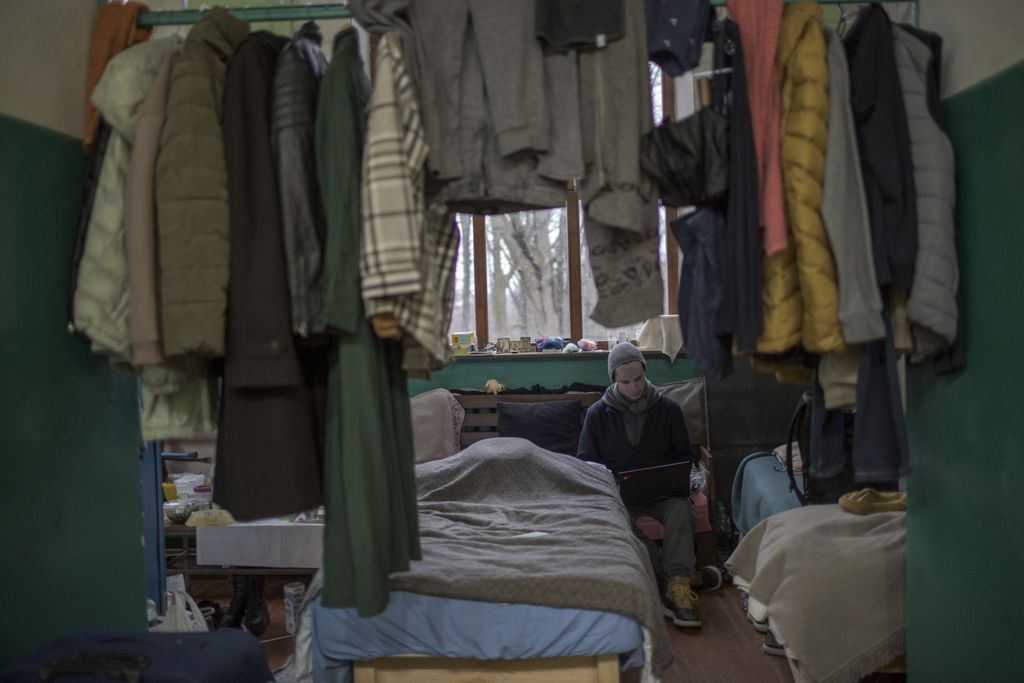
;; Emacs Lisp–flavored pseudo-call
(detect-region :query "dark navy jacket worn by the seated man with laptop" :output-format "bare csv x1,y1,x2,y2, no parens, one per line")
577,396,693,472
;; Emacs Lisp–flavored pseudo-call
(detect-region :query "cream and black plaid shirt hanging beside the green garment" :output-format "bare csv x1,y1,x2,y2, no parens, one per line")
360,33,459,378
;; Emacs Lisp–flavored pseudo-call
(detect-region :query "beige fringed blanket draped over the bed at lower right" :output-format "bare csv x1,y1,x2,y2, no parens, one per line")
726,505,906,683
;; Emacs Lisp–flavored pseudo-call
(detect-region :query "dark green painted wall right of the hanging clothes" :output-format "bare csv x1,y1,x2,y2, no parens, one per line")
907,62,1024,682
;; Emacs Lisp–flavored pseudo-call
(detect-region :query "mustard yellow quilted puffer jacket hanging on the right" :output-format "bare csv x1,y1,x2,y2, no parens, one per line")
758,3,844,353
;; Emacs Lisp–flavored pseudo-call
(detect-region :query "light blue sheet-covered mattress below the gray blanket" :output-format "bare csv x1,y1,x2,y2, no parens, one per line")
309,591,643,683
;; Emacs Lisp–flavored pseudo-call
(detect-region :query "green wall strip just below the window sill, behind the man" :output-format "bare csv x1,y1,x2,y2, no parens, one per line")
409,351,697,396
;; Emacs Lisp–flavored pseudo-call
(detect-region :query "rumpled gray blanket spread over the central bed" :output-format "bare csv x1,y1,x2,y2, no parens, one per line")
391,438,672,674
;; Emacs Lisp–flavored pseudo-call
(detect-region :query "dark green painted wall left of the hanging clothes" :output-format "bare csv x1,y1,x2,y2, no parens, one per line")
0,116,145,668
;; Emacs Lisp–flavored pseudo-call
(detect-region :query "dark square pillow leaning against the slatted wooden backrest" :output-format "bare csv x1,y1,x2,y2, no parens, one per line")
498,400,583,456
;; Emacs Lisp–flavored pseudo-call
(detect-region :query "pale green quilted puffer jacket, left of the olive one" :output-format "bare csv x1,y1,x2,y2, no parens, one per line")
72,36,181,359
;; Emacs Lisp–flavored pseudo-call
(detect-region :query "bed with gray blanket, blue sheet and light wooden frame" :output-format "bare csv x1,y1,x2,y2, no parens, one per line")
278,393,672,683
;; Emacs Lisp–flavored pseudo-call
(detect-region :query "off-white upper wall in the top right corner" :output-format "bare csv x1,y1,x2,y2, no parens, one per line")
919,0,1024,97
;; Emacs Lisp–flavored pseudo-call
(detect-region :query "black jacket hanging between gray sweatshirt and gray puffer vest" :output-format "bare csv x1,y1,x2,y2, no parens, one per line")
843,4,918,292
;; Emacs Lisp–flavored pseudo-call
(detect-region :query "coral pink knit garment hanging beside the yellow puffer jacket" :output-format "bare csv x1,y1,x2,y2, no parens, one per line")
726,0,787,254
